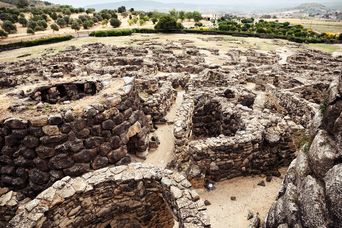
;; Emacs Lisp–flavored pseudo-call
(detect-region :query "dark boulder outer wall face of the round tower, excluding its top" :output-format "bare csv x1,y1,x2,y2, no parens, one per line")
0,78,150,196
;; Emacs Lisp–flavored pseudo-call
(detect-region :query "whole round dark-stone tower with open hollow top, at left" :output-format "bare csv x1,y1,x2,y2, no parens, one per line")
0,76,150,197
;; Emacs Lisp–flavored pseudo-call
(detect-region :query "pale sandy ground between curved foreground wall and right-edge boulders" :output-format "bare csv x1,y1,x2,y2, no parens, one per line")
197,168,286,228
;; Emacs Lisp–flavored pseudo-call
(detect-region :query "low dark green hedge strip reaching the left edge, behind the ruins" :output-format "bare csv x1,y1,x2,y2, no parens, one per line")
0,35,74,51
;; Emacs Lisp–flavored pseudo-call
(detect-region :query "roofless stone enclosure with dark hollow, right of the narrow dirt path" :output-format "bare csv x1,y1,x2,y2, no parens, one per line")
169,90,297,187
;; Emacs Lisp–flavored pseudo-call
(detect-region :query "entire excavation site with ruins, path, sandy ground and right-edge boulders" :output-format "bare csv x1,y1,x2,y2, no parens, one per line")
0,34,342,228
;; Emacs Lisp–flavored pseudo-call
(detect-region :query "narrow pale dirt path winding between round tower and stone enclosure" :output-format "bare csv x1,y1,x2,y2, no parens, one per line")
144,91,184,168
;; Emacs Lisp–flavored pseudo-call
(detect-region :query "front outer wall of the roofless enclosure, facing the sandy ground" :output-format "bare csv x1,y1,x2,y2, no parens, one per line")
188,128,295,181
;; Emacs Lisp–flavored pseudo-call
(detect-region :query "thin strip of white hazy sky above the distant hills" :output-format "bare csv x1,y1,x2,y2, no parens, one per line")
50,0,329,6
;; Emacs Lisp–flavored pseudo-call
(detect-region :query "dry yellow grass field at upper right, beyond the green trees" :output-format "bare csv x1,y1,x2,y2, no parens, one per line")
269,18,342,33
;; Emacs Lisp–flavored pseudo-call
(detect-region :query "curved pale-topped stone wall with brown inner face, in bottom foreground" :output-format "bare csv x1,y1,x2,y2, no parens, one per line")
8,164,210,228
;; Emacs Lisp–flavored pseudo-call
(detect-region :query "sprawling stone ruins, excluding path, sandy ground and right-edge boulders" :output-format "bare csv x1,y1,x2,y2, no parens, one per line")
0,40,342,227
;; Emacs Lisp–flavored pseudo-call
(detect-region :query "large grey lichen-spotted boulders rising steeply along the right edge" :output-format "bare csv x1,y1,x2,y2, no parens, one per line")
265,77,342,228
